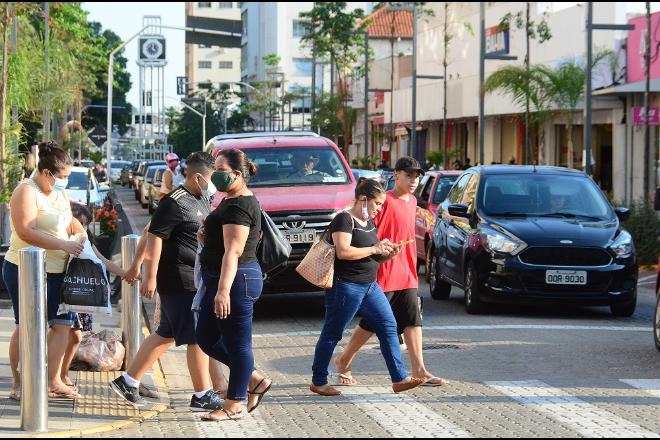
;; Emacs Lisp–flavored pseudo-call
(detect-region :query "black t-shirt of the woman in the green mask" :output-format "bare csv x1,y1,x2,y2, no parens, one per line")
200,196,261,274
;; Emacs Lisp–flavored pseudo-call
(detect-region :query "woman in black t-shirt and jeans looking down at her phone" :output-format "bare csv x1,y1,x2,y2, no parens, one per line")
309,179,424,396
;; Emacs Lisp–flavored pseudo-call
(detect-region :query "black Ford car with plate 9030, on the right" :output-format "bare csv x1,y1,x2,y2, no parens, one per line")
430,166,637,316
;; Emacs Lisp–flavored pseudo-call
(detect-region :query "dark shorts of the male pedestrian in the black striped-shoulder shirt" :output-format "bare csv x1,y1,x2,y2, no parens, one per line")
156,292,197,347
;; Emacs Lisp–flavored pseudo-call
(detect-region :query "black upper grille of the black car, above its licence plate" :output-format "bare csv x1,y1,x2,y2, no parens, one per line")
520,247,612,267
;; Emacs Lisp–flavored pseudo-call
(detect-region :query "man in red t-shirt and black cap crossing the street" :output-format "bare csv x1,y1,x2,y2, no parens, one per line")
334,157,444,386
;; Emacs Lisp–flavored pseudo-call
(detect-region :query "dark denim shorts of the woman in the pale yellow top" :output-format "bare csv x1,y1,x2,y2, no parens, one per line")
2,260,77,327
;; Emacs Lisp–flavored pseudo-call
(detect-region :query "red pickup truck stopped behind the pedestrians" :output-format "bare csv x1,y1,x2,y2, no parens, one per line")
206,131,356,293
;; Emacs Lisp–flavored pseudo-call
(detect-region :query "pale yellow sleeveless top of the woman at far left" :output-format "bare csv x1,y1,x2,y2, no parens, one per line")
5,179,73,273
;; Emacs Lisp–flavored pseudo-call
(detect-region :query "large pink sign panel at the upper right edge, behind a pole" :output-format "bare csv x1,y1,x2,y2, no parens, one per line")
626,12,660,83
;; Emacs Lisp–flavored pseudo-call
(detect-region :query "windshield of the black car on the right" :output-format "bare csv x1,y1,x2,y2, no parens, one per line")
479,174,613,220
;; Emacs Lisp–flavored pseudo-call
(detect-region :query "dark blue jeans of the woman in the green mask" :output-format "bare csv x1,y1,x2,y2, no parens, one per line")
196,262,263,400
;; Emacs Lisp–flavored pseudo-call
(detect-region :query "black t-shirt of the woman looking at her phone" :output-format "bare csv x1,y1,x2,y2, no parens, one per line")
330,212,380,284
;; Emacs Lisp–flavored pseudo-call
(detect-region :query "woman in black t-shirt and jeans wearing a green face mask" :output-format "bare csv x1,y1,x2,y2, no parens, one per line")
196,150,272,421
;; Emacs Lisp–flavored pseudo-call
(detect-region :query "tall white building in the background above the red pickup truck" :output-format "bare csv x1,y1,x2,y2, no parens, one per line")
241,2,368,129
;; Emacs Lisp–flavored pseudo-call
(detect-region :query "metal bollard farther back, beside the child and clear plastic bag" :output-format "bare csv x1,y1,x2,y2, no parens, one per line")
121,234,142,368
